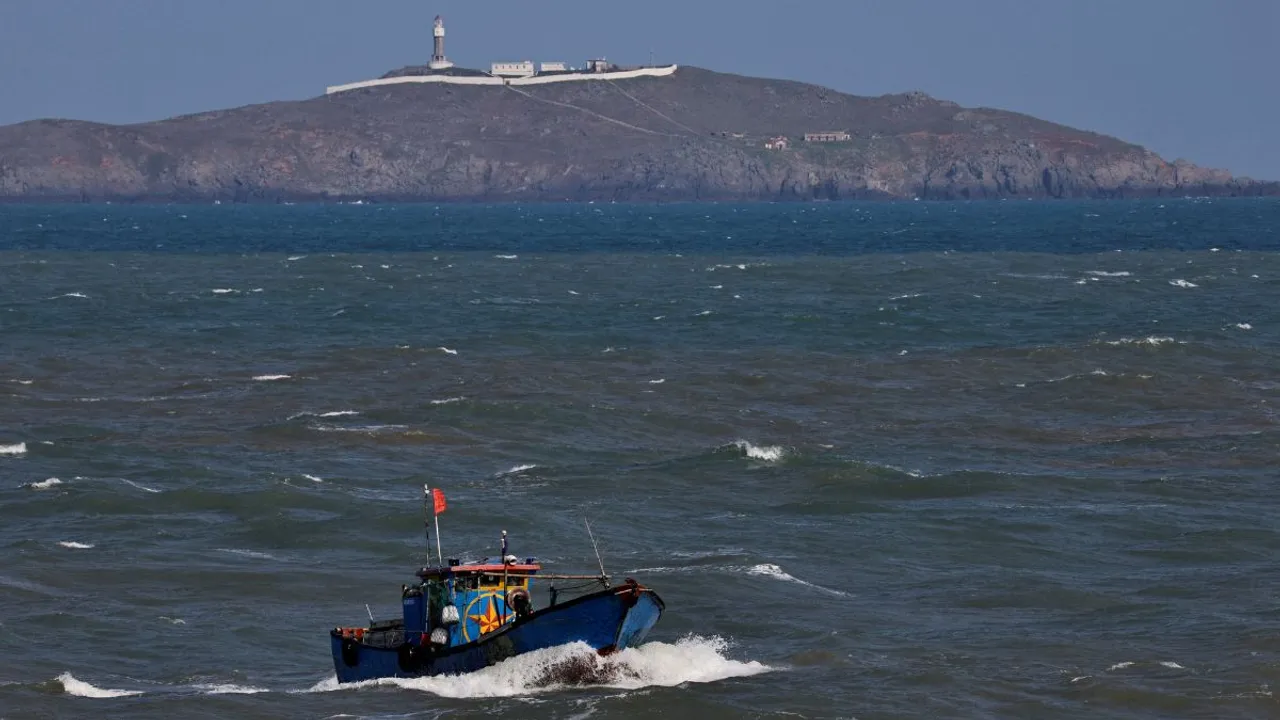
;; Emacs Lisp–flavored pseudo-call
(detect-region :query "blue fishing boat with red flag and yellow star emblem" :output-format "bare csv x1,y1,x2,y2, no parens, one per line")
329,488,666,683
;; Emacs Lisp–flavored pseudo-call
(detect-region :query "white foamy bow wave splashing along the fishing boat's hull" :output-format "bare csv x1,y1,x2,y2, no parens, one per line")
306,635,773,698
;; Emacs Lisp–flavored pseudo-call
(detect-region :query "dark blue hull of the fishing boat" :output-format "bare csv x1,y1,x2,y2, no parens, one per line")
330,585,664,683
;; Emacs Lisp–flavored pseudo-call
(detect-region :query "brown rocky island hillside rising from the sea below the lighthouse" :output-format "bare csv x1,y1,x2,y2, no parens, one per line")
0,68,1280,201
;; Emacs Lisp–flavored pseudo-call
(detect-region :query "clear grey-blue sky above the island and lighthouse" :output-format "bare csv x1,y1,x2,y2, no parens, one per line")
0,0,1280,179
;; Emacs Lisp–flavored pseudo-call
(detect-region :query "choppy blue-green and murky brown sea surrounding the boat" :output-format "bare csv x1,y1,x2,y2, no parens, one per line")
0,199,1280,720
